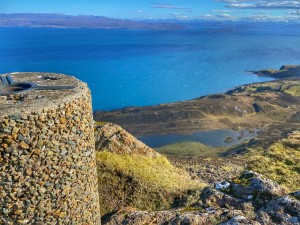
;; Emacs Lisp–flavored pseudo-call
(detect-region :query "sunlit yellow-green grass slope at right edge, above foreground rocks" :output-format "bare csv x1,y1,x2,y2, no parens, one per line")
245,134,300,191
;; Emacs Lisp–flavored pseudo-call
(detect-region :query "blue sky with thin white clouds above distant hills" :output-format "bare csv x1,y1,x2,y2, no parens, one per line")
0,0,300,21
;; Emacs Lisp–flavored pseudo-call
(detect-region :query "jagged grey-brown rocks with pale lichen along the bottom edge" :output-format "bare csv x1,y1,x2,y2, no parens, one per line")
104,171,300,225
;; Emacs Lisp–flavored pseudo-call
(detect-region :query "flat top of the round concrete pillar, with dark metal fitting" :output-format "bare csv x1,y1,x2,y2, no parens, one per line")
0,72,89,117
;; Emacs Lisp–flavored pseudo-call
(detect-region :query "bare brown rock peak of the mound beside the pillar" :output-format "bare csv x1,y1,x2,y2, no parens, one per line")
95,123,159,157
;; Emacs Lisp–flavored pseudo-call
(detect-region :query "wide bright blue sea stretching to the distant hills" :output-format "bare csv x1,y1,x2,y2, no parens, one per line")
0,28,300,110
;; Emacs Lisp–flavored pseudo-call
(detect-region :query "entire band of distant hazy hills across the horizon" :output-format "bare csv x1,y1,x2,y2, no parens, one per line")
0,13,300,34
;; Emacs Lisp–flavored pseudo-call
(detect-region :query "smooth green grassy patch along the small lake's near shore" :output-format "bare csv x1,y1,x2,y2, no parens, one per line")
155,142,226,157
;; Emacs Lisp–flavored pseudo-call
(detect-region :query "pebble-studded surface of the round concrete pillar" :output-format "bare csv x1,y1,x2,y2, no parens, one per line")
0,73,100,225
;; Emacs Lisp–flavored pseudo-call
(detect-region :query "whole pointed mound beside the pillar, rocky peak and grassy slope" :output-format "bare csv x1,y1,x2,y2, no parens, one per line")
95,123,207,216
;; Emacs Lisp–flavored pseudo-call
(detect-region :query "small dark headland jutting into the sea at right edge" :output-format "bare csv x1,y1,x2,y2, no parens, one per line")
250,65,300,79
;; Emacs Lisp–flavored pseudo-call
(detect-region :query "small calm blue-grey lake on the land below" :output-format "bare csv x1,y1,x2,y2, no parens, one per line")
138,130,258,148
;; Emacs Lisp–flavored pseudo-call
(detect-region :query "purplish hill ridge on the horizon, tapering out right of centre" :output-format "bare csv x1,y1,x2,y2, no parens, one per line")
0,13,184,30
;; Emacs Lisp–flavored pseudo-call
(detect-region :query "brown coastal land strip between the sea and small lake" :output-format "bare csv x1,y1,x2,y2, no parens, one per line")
94,66,300,148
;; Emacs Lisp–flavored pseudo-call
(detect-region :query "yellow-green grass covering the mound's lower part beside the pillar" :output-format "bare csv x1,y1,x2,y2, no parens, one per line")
97,151,205,215
